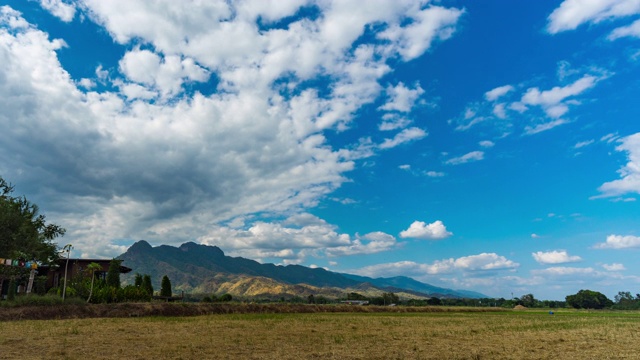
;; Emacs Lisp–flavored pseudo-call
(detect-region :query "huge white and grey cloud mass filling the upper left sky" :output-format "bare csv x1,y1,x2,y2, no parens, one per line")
0,0,463,256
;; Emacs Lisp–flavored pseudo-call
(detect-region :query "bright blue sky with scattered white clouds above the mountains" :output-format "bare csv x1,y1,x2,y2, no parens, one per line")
0,0,640,299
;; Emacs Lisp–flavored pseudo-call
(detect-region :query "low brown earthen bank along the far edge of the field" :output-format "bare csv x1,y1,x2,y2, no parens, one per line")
0,303,504,321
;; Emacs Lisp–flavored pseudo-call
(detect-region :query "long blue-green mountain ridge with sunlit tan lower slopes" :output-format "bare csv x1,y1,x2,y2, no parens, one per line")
118,240,486,297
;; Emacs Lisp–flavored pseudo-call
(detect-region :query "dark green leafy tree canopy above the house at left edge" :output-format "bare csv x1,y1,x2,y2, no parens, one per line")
0,177,65,263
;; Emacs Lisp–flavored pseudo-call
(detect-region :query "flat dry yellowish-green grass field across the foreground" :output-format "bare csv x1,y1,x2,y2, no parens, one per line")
0,310,640,359
